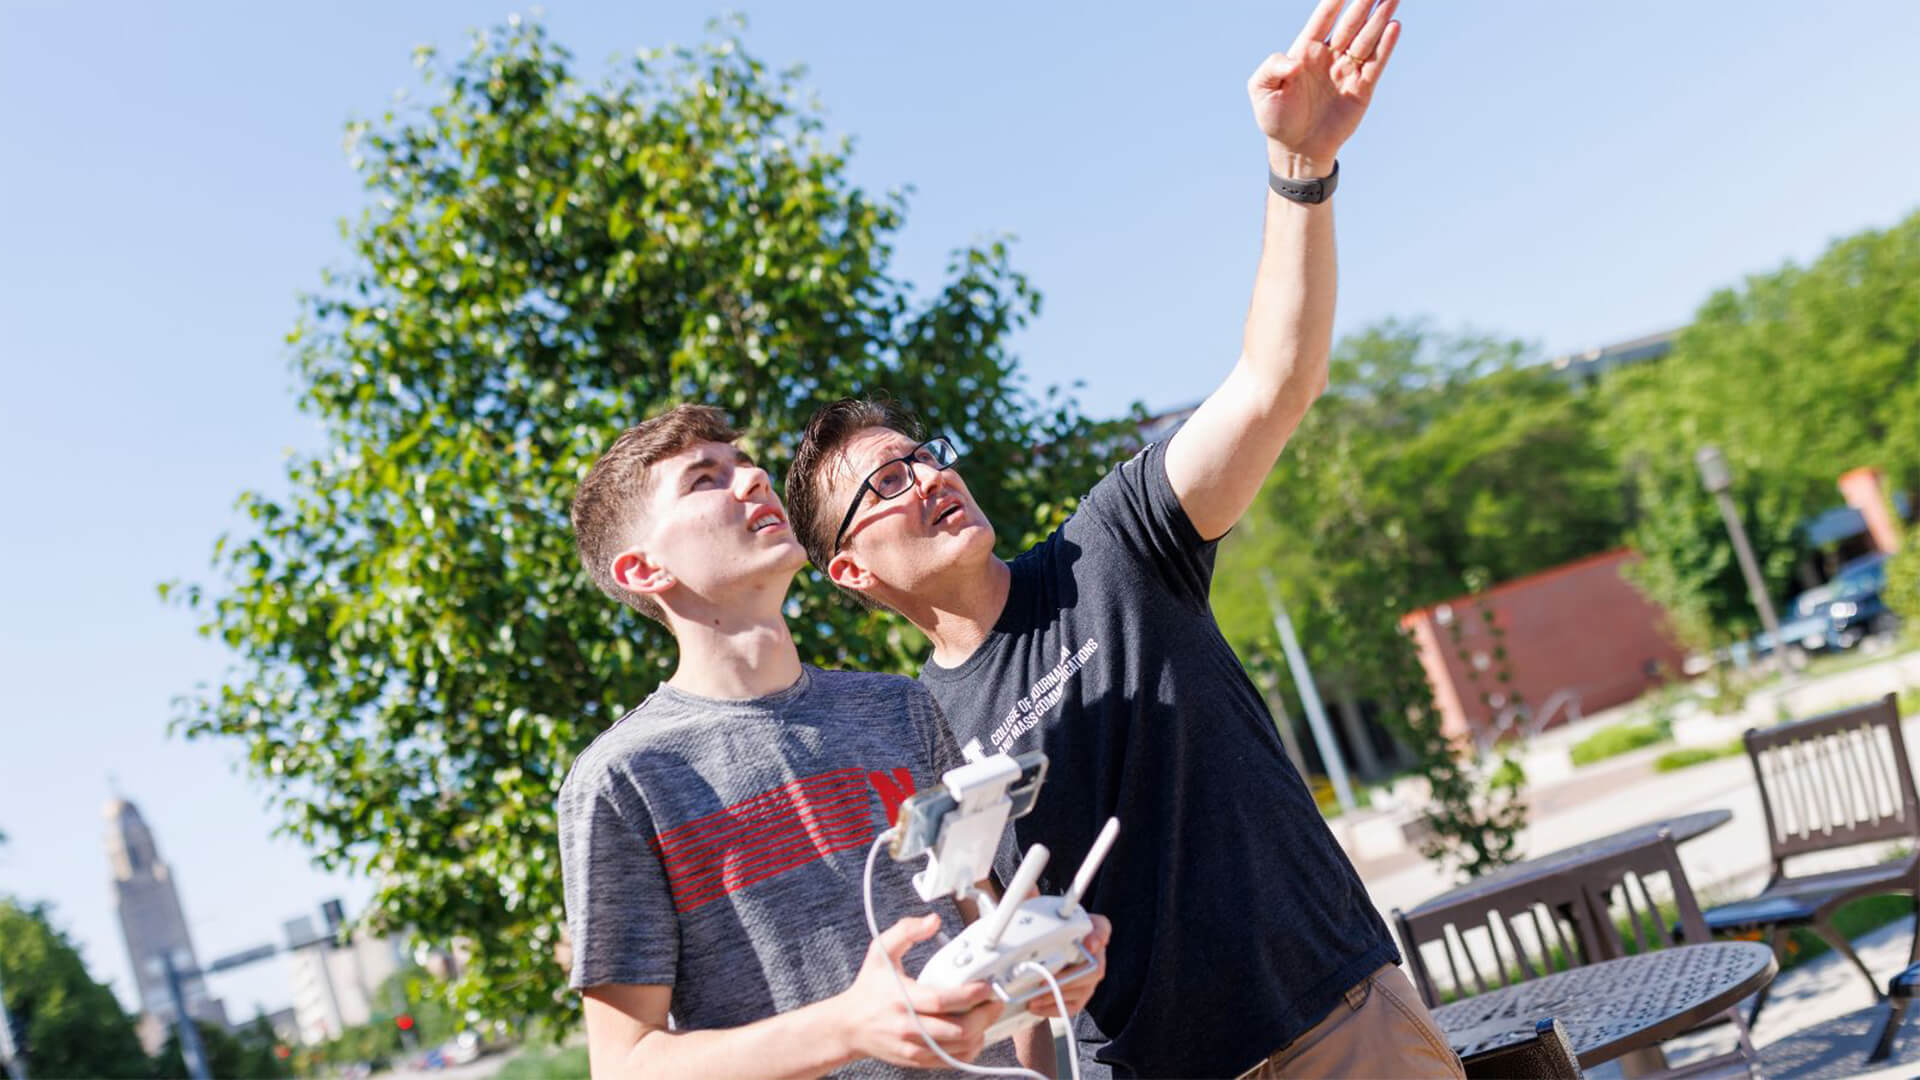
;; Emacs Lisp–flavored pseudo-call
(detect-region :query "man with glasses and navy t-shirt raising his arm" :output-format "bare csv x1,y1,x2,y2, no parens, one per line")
787,0,1461,1076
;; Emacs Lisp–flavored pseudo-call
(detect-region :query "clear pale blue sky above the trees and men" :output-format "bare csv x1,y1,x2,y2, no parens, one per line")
0,0,1920,1013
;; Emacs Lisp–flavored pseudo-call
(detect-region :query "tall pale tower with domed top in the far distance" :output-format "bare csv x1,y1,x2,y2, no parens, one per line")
106,799,227,1053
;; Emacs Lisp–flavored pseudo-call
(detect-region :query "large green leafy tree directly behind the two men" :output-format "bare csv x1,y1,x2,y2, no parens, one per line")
163,23,1121,1022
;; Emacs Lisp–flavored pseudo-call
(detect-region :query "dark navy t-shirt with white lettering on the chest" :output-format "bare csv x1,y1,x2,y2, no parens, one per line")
920,444,1400,1076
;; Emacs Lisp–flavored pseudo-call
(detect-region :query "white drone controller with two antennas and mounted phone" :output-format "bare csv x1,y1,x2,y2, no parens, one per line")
893,742,1119,1043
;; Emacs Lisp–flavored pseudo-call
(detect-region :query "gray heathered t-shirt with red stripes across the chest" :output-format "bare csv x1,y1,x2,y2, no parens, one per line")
559,667,1014,1076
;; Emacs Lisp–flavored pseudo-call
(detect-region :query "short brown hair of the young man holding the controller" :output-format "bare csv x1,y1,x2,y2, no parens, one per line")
572,405,739,626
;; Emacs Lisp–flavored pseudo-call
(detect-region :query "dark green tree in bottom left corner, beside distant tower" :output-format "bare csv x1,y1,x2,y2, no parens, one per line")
0,897,152,1078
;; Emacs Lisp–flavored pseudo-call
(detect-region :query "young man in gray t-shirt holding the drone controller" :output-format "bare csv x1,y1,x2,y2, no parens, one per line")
559,405,1106,1078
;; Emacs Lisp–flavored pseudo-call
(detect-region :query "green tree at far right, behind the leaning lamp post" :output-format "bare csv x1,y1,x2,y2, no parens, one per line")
1601,213,1920,646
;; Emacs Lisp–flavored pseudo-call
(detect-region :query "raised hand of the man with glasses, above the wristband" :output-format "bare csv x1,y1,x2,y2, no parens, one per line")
1246,0,1400,175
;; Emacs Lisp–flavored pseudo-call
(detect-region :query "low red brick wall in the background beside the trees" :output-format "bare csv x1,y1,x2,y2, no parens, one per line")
1402,550,1686,736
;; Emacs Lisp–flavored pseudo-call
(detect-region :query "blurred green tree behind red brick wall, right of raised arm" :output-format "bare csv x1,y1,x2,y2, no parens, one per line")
1215,321,1624,638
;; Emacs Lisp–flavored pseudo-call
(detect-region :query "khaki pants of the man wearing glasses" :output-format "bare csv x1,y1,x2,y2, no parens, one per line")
1242,965,1467,1080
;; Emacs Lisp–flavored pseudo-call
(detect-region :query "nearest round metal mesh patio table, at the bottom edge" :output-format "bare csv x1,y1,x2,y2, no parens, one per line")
1432,942,1780,1068
